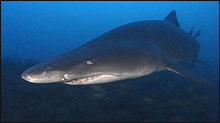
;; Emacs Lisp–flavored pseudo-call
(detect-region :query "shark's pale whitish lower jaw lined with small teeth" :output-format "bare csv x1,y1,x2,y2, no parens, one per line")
63,74,123,85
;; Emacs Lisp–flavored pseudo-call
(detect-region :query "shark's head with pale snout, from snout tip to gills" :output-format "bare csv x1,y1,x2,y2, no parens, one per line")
22,40,162,85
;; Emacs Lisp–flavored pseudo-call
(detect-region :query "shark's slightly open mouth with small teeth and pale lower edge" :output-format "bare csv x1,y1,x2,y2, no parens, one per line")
64,74,120,85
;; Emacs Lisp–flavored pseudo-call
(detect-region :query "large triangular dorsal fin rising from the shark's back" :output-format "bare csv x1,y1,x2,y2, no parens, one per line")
164,10,180,27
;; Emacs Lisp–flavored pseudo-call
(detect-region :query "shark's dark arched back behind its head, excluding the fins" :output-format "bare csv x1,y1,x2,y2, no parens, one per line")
90,11,200,61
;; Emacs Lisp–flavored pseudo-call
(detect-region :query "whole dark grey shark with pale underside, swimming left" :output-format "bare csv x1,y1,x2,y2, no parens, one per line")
22,10,215,85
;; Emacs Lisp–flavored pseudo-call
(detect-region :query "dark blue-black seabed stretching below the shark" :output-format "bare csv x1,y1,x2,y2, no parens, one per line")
1,58,219,122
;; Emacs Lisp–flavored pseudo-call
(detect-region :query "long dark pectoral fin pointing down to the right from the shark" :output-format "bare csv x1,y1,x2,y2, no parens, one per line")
165,62,218,88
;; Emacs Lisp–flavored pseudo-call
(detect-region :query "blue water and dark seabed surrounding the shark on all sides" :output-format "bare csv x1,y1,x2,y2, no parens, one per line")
1,1,219,122
